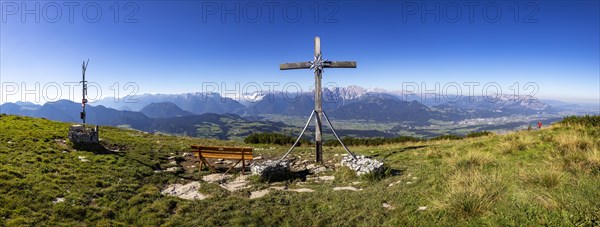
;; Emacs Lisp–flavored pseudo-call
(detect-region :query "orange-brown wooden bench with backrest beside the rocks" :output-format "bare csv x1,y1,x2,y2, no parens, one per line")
192,145,253,174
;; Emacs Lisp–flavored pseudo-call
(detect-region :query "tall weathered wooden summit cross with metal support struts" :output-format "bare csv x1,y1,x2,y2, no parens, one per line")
279,36,356,162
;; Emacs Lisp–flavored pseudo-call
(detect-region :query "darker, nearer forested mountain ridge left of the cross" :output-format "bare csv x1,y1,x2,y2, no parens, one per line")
0,100,289,139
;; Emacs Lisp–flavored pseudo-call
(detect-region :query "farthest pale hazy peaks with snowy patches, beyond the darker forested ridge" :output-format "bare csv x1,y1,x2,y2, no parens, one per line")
94,86,576,119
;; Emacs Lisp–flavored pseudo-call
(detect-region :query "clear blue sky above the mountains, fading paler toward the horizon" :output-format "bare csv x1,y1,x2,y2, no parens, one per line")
0,0,600,103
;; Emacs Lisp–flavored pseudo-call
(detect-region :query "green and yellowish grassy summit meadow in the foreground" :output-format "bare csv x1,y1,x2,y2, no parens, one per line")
0,115,600,226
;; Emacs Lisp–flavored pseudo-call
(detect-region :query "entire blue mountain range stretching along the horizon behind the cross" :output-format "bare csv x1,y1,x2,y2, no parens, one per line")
0,86,593,139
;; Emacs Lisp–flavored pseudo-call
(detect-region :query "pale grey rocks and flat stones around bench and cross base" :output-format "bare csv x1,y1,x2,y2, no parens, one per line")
161,153,384,200
